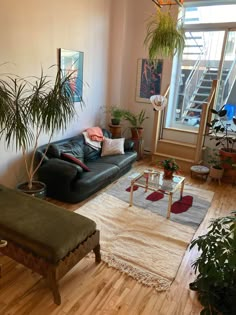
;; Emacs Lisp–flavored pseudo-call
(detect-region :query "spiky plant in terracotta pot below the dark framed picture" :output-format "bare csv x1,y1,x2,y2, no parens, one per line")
124,109,149,139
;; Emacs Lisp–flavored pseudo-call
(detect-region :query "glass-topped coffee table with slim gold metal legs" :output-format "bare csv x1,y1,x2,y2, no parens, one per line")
129,169,185,219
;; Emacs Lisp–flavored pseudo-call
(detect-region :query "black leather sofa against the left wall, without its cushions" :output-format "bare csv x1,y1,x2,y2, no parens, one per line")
36,129,137,203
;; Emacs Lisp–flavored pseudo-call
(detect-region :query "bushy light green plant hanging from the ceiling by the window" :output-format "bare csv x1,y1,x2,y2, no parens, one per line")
144,9,185,60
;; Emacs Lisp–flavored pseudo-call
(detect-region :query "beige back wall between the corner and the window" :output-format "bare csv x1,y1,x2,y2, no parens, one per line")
109,0,173,151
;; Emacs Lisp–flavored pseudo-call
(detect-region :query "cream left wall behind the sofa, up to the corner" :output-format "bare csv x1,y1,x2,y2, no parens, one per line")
0,0,112,186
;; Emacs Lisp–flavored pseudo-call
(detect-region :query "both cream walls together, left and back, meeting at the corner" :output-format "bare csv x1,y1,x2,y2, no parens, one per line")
0,0,175,187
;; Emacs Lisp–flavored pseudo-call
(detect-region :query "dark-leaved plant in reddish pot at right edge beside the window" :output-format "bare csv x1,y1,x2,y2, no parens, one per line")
206,105,236,181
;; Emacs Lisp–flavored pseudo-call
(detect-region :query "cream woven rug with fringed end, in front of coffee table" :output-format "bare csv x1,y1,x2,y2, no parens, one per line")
75,193,195,291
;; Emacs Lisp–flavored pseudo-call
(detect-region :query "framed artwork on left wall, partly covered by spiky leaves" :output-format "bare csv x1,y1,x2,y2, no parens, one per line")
59,48,84,102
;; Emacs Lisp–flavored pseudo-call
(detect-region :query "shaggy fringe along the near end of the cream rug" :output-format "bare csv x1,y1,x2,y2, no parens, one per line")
101,253,171,292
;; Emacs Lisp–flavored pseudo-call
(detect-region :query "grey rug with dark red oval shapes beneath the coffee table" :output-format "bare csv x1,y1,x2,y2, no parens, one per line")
106,177,214,229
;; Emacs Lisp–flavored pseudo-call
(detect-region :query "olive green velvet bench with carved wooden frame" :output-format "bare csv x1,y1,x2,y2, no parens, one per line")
0,185,101,305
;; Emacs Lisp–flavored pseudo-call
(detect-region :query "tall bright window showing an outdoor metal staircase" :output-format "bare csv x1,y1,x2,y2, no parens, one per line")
165,1,236,131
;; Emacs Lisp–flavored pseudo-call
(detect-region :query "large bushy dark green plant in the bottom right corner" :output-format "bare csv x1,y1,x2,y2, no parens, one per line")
189,211,236,314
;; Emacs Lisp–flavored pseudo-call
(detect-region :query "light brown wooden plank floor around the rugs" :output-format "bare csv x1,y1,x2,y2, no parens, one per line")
0,160,236,315
